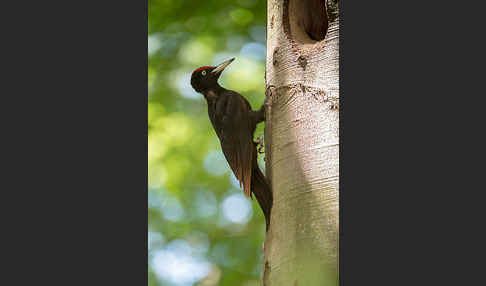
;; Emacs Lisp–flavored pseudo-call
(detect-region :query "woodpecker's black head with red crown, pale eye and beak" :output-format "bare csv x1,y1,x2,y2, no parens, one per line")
191,58,235,93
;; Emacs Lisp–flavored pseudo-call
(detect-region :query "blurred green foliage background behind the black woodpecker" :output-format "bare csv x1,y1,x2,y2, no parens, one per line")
148,0,266,286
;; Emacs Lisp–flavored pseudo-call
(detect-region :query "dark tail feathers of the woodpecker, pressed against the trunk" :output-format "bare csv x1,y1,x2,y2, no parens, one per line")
251,163,273,230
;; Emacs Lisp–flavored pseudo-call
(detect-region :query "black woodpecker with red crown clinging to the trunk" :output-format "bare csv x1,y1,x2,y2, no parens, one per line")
191,58,273,231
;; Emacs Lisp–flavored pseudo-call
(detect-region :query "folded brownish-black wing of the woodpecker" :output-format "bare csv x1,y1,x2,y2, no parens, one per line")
216,91,256,198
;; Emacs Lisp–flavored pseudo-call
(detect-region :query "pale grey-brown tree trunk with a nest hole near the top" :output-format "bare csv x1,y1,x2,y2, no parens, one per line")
262,0,339,286
